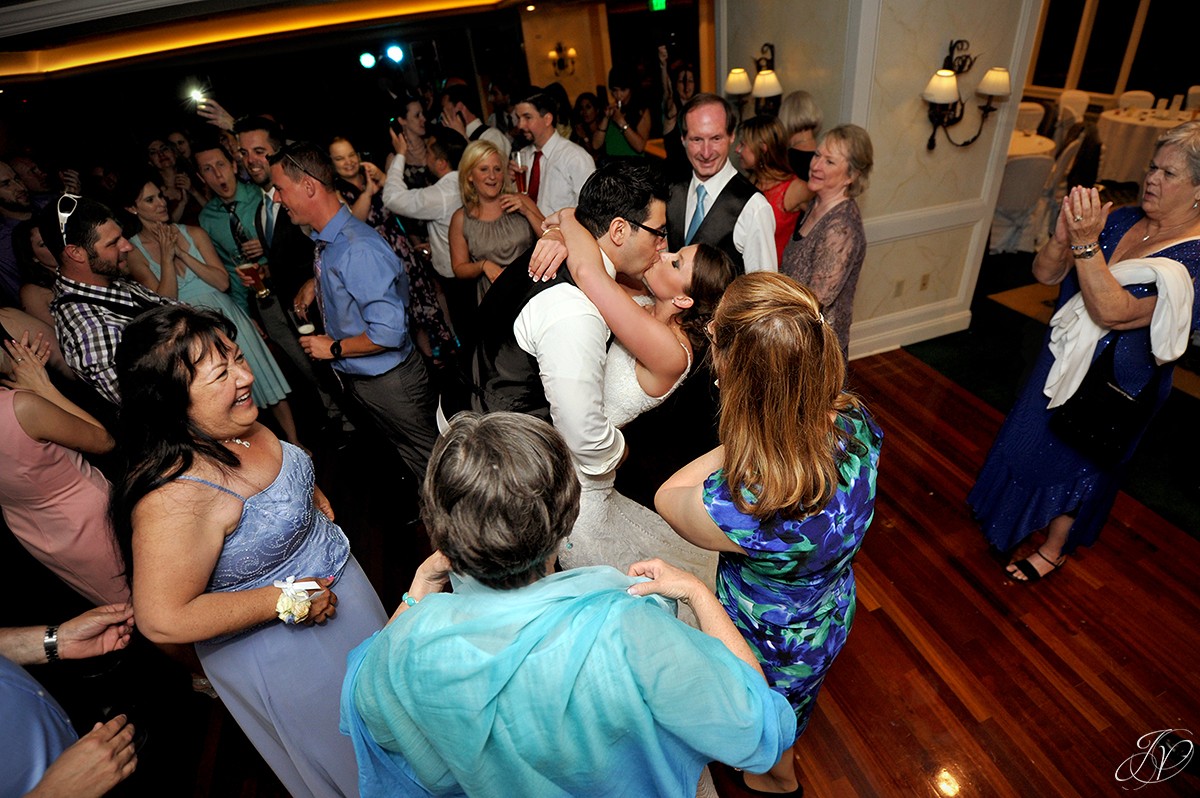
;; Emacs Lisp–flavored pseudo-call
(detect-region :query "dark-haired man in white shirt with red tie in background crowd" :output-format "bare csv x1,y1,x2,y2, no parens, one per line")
514,92,595,216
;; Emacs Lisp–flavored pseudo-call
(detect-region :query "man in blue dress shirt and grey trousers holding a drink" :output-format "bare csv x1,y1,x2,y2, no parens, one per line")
270,143,437,479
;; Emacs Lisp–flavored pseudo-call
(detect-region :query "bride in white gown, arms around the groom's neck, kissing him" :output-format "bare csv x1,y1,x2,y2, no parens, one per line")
529,209,734,588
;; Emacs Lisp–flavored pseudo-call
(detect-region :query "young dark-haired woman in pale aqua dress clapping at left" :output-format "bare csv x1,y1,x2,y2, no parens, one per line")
118,174,300,445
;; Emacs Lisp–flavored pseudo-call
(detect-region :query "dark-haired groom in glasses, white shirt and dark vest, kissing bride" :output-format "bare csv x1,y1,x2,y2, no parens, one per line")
439,161,667,480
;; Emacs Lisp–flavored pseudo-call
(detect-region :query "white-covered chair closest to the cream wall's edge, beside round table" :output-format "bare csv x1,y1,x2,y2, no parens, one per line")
988,155,1055,252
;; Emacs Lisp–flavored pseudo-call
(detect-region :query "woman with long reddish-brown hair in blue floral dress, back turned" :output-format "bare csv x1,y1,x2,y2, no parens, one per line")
655,272,883,796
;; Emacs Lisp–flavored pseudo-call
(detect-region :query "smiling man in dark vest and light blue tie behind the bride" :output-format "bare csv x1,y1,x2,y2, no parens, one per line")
667,94,779,274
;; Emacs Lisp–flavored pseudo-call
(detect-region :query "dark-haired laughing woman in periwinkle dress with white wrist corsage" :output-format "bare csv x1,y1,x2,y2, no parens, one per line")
112,305,388,797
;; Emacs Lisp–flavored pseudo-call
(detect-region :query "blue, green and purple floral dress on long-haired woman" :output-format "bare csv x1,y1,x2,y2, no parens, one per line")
704,410,883,734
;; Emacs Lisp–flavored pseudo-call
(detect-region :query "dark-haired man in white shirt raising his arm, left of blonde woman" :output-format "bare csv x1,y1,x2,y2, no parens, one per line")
383,128,467,280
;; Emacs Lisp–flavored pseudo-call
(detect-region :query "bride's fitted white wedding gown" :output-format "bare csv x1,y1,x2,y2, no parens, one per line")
559,298,718,590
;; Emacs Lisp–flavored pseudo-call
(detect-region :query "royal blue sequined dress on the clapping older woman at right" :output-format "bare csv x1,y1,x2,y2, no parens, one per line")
967,208,1200,552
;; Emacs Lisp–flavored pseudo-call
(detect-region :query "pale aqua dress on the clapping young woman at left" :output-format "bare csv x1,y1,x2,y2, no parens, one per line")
130,224,292,408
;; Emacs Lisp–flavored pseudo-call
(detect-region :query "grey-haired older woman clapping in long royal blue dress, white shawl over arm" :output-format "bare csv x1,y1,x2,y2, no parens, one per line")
967,121,1200,582
